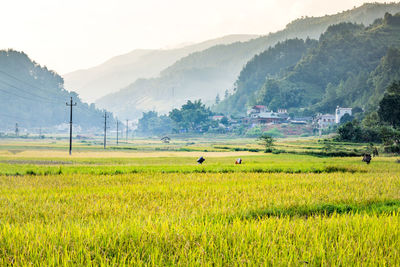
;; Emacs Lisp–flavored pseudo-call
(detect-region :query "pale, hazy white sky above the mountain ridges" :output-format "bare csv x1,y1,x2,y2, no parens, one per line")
0,0,394,74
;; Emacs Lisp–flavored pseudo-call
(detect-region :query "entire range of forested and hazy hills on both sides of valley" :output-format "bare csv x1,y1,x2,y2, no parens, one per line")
0,3,400,132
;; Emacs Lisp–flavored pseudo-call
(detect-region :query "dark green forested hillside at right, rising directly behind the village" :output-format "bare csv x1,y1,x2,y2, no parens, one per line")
217,14,400,114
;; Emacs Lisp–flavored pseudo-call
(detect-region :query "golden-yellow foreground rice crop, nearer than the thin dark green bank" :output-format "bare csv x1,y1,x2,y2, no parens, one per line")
0,170,400,266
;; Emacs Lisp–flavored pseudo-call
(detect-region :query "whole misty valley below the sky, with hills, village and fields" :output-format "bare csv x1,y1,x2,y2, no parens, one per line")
0,1,400,266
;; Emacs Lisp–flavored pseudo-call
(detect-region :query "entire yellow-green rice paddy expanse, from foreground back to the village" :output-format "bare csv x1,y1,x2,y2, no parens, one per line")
0,139,400,266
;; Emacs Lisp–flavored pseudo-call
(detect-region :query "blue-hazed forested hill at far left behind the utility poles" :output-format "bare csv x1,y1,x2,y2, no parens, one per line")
0,50,113,130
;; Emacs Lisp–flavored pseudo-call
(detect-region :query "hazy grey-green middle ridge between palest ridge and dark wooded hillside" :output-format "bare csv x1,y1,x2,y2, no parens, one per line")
96,3,400,118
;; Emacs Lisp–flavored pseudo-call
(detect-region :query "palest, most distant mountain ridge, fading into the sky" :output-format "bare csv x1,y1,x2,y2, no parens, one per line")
63,34,257,101
